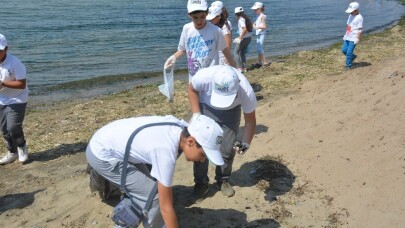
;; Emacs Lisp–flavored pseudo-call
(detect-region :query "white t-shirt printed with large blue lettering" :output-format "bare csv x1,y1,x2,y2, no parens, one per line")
178,21,226,82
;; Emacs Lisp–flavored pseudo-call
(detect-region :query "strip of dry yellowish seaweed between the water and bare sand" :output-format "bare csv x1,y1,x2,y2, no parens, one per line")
24,14,405,152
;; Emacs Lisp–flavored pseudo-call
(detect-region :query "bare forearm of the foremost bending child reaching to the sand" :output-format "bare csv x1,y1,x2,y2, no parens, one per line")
158,182,179,228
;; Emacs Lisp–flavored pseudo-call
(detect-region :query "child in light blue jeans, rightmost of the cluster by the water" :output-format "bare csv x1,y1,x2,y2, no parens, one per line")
252,2,268,68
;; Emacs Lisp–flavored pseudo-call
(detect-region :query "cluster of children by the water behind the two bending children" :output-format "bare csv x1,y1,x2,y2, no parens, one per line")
165,0,268,75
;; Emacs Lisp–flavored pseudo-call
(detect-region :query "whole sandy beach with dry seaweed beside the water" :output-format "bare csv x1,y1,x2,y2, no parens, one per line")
0,17,405,227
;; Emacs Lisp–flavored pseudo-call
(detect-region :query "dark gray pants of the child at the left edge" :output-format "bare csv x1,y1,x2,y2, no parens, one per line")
0,103,27,153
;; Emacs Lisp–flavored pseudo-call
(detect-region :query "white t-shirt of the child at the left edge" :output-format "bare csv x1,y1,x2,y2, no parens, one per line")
0,53,28,105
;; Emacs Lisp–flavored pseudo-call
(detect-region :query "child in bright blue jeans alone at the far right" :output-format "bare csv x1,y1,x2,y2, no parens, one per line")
342,2,363,69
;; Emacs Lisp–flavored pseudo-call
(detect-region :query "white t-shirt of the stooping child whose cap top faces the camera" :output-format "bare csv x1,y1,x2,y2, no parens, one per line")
191,65,257,113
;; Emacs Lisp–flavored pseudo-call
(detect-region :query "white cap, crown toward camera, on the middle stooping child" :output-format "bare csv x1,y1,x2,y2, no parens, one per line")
211,65,239,108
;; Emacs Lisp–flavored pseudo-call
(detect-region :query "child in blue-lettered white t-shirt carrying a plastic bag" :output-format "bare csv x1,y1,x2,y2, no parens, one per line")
164,0,236,81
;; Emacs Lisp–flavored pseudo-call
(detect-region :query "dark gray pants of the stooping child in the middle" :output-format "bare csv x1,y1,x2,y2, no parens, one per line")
194,103,241,184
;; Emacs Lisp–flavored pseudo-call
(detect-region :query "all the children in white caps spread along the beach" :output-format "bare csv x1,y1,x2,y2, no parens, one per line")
0,0,363,227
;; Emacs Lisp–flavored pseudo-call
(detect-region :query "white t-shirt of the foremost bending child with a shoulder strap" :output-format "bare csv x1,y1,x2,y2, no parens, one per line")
89,116,188,187
